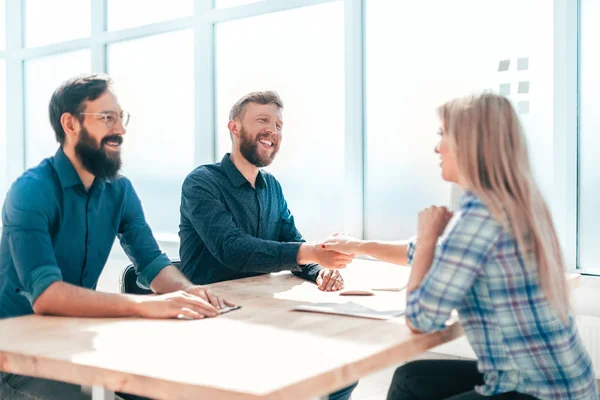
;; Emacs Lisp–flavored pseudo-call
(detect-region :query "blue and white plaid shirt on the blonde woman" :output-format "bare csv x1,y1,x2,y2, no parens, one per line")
406,192,598,400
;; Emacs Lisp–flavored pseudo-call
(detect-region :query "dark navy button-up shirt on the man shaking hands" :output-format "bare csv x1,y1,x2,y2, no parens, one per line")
179,154,321,285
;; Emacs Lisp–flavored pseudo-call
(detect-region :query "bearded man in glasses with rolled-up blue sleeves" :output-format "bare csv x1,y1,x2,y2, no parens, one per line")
0,75,228,399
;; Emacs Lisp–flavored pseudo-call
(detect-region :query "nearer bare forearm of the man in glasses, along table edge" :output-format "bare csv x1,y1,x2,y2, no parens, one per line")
33,282,139,318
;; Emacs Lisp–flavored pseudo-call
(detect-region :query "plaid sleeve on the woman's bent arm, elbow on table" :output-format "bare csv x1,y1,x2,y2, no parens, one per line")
406,212,500,332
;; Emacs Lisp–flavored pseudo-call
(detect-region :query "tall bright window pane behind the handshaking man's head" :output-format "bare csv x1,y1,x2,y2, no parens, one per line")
216,2,344,240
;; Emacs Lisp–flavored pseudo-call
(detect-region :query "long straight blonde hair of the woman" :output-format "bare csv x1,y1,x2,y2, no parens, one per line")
438,92,570,320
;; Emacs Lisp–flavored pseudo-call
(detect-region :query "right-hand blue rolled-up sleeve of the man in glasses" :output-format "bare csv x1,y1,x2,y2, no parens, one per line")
119,178,171,289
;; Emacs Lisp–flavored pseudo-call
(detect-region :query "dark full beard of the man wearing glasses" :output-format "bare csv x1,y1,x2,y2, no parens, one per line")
75,128,123,179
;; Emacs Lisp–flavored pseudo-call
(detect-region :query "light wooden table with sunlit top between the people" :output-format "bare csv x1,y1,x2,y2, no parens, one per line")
0,260,462,400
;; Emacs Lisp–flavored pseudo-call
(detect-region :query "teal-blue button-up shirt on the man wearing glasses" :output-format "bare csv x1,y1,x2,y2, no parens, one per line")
0,149,170,318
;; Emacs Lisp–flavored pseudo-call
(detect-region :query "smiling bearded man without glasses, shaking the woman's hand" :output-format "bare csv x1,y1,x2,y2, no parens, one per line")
179,91,354,399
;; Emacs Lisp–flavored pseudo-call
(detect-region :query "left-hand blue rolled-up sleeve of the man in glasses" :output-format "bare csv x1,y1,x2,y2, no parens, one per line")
2,179,63,306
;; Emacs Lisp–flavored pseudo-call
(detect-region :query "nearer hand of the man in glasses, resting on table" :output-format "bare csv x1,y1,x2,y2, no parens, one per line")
136,290,219,319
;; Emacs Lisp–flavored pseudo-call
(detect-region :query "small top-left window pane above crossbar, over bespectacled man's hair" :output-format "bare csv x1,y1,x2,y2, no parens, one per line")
25,0,91,47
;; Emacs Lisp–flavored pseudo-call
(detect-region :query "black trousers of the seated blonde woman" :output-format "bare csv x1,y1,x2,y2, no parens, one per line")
387,360,535,400
